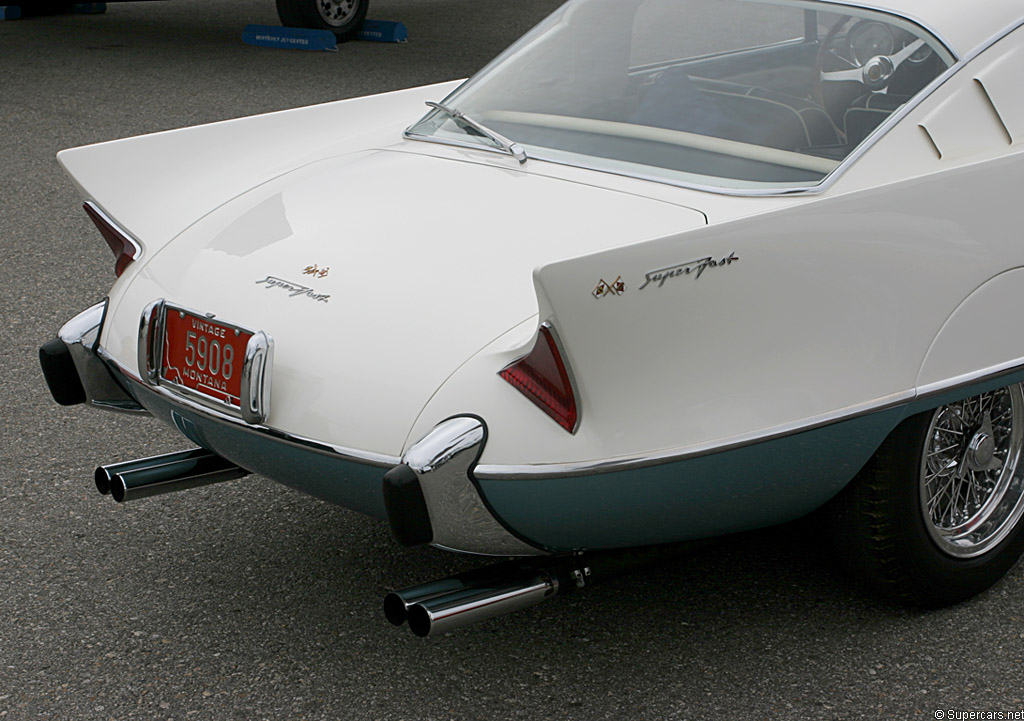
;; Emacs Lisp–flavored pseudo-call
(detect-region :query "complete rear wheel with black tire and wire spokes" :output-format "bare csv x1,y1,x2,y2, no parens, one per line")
826,383,1024,608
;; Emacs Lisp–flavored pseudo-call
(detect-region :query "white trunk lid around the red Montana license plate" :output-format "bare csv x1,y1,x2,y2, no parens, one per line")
101,143,705,456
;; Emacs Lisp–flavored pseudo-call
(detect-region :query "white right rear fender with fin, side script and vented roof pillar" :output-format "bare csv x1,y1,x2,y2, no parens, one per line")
417,23,1024,467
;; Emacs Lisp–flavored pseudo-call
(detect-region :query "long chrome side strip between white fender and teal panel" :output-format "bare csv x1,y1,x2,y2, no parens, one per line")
474,357,1024,480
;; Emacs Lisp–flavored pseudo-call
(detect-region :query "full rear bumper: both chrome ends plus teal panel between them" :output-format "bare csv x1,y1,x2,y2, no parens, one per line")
40,300,546,556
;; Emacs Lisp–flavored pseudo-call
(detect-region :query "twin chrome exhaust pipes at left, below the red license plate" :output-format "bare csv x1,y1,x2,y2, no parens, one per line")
93,449,249,503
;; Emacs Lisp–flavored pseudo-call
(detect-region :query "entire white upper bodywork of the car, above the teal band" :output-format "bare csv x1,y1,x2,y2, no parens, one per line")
61,9,1024,468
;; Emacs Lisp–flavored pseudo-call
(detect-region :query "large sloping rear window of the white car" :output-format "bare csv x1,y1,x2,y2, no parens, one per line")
409,0,953,190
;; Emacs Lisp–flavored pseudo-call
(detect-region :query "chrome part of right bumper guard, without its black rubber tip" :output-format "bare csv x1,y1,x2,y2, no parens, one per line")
401,416,544,556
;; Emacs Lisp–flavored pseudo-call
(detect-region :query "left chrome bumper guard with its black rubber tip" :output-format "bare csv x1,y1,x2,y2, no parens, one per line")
39,300,147,413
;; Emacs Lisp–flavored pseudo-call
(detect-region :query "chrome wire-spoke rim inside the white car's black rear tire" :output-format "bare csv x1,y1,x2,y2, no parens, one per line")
920,385,1024,558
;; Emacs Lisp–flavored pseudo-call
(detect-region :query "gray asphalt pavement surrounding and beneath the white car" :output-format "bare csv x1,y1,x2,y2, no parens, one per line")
0,0,1024,721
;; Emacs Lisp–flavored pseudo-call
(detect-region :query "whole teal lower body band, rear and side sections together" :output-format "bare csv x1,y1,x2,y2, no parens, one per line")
125,358,1024,552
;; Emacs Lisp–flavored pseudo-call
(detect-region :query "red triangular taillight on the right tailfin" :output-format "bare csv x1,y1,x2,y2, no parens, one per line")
500,326,579,433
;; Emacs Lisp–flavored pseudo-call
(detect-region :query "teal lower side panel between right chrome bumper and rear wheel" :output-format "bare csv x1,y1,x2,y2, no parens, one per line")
477,407,907,551
